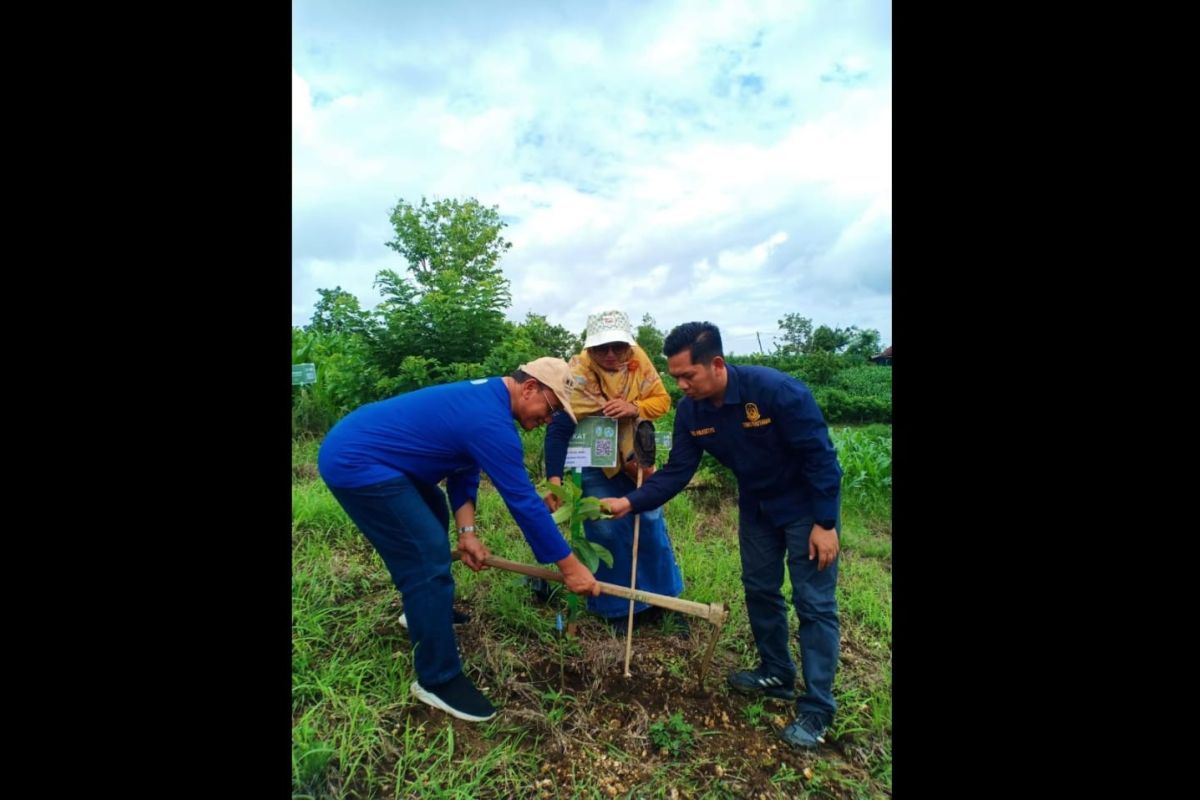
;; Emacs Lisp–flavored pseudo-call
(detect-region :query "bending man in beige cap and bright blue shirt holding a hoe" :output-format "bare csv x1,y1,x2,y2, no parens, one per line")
317,357,600,722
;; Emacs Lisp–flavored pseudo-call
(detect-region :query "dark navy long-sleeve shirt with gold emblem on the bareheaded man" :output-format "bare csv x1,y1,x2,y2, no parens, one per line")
625,365,842,525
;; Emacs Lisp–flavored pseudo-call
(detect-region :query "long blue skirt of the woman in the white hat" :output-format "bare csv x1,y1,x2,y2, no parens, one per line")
583,467,683,618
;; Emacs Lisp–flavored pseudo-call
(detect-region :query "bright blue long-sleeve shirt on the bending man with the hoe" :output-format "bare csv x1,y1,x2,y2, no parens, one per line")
317,378,571,564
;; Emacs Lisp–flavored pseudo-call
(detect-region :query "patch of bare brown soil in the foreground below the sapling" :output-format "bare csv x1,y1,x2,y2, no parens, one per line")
367,602,890,798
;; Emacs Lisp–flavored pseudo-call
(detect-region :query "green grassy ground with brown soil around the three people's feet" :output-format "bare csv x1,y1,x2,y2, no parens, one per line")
292,426,892,800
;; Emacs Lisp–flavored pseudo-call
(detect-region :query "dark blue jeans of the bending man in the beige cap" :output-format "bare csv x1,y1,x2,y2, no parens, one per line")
329,477,462,687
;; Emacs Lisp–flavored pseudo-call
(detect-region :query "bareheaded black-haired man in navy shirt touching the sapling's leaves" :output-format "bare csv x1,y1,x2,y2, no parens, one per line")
601,323,842,747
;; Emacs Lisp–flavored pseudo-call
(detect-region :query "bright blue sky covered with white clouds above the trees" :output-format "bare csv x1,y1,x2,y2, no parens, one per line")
292,0,892,353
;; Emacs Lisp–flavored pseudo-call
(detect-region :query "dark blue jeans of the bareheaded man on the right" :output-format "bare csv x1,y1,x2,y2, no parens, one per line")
738,509,841,724
